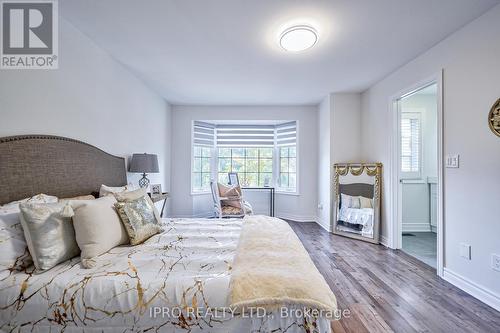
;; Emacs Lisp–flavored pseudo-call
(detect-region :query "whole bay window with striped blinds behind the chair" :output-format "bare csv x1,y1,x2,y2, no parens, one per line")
191,121,298,193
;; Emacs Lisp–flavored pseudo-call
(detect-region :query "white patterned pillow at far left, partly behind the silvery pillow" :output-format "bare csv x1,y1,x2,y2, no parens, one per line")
0,194,57,278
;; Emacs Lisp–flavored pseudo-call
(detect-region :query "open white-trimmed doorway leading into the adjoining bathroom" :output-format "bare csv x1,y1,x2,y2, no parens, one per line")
392,77,443,276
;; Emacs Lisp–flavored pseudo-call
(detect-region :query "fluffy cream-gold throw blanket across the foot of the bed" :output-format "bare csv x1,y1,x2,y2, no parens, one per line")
229,216,337,312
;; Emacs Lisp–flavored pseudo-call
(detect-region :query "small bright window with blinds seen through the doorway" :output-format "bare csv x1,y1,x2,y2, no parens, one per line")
401,112,422,178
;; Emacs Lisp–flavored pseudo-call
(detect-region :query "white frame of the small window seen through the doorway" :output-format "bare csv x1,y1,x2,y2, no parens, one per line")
399,109,424,180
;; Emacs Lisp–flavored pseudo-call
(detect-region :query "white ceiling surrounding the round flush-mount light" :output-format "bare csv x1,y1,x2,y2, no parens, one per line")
59,0,500,105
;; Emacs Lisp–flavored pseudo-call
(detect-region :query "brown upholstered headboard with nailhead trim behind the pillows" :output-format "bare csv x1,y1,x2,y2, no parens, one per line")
0,135,127,204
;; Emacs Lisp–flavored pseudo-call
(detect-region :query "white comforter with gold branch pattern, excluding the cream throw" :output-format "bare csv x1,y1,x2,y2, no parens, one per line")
0,219,330,332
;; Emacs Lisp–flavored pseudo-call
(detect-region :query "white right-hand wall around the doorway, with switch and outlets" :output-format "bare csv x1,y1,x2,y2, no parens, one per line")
362,5,500,308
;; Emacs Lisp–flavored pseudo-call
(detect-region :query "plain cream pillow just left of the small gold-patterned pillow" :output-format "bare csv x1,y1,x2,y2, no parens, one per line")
71,196,128,268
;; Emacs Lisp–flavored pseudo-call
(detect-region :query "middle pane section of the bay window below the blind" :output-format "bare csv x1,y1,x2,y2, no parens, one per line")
217,147,273,187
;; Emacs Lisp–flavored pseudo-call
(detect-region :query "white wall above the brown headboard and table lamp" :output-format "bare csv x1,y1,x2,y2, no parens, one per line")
0,18,171,213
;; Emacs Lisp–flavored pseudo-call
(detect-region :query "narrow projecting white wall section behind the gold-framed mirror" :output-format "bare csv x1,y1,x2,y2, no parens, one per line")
317,93,362,230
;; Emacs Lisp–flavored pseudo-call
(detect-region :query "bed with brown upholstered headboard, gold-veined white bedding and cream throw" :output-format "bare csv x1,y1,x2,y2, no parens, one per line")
0,135,337,332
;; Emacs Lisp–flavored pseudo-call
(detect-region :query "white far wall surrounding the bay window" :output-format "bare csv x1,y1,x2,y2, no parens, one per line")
172,106,318,221
